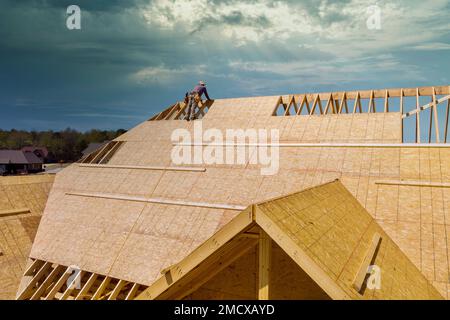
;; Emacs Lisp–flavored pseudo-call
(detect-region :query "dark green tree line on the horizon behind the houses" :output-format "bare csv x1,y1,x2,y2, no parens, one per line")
0,128,126,162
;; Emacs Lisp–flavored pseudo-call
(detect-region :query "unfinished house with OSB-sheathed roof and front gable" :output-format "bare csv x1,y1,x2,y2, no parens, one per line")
17,86,450,300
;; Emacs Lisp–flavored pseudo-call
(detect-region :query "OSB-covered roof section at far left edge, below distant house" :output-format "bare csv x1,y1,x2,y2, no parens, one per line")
0,175,54,299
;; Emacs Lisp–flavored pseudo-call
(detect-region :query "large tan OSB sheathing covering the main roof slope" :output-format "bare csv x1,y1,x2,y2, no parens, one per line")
28,97,450,295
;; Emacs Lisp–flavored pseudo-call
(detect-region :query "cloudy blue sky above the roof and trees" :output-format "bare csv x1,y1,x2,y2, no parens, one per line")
0,0,450,130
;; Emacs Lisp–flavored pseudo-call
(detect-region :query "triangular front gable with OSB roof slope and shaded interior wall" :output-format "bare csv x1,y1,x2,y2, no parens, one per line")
139,181,443,299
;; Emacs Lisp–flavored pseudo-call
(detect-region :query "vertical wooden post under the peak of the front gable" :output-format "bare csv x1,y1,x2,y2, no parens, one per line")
258,230,272,300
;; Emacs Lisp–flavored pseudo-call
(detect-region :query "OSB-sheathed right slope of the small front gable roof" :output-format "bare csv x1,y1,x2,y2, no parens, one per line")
257,182,441,299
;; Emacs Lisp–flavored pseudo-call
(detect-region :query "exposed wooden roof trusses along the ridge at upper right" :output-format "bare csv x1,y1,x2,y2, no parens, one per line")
273,86,450,143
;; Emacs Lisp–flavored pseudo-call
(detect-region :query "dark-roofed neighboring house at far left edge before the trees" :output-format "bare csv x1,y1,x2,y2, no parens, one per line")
0,150,44,175
